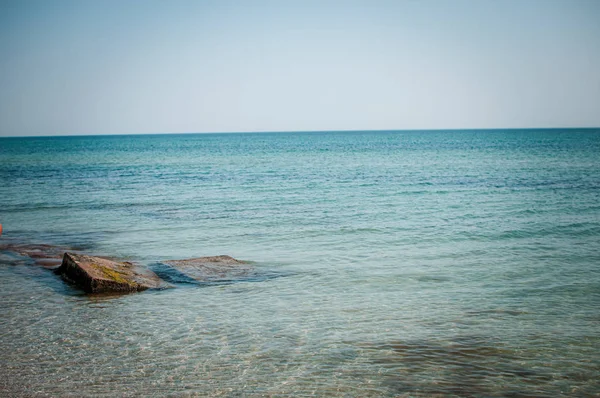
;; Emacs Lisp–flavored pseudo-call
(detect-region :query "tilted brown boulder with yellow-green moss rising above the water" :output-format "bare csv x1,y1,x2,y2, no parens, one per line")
56,253,164,293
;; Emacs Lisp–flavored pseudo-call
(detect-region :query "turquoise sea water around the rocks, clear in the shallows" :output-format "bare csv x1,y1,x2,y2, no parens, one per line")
0,129,600,397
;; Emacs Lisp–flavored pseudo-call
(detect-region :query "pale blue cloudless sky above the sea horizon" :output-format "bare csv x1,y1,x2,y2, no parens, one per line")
0,0,600,136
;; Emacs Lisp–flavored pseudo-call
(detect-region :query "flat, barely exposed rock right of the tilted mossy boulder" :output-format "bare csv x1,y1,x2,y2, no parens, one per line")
163,256,253,282
